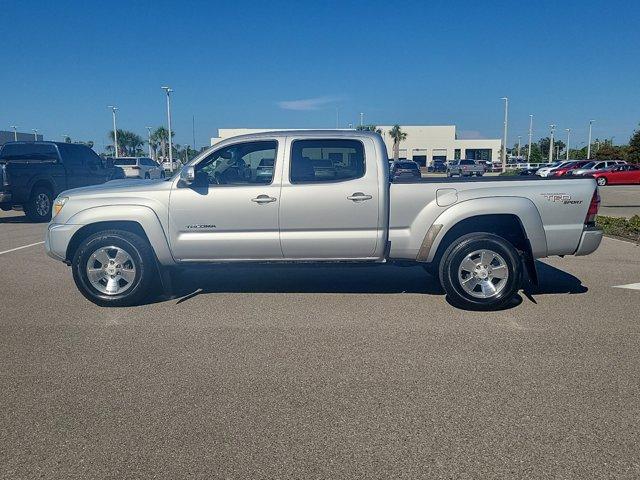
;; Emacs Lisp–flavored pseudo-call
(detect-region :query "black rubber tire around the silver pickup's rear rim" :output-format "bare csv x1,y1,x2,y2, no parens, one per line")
439,233,522,310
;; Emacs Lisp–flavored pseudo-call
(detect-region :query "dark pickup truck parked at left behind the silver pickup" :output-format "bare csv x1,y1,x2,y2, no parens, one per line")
0,142,124,222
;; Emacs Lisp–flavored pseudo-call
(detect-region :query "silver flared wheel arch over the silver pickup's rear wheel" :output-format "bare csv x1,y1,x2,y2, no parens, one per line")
426,197,547,262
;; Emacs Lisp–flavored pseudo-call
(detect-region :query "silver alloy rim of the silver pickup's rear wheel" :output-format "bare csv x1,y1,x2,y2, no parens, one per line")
458,249,509,299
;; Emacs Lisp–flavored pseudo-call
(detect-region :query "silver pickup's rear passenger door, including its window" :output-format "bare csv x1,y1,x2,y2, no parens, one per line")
280,137,383,260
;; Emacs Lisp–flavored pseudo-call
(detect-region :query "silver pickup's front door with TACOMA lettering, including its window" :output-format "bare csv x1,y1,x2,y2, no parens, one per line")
169,140,282,261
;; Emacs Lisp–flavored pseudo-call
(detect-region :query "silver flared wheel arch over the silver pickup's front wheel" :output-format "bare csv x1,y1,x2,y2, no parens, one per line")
66,205,175,265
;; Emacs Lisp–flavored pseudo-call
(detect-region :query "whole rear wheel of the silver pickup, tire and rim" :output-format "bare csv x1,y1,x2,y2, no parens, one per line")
439,233,522,310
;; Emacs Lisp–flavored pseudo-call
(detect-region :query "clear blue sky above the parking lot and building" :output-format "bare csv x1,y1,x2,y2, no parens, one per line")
0,0,640,150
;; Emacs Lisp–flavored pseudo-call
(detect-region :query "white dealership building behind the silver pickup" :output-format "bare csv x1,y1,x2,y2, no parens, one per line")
211,125,502,166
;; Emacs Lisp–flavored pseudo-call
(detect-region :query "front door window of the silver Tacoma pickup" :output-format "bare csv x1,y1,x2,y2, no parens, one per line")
196,140,278,185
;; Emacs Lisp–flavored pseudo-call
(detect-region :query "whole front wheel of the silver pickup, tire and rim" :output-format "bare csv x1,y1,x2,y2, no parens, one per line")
72,230,157,307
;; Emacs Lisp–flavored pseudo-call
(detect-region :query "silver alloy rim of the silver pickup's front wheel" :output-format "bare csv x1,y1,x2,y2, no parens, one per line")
86,246,136,295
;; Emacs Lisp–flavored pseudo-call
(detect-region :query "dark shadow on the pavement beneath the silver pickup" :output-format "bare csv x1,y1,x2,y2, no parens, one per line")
164,262,588,309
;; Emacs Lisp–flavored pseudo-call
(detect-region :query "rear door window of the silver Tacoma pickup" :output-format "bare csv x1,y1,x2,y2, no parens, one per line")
289,139,365,184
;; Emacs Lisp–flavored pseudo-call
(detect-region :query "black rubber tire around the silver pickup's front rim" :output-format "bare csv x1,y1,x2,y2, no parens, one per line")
71,230,158,307
